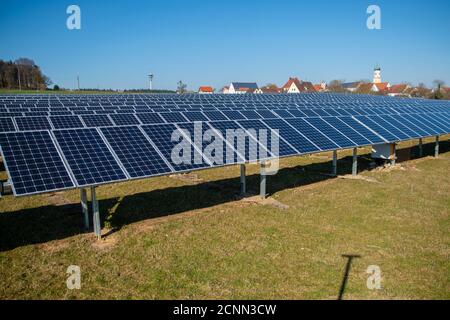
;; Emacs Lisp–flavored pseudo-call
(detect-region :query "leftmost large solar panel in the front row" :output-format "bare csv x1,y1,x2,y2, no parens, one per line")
0,131,75,196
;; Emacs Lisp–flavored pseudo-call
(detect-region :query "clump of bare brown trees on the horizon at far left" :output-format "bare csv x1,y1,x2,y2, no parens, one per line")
0,58,52,90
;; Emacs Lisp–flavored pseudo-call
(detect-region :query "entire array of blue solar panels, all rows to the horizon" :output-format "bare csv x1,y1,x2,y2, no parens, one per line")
0,94,450,196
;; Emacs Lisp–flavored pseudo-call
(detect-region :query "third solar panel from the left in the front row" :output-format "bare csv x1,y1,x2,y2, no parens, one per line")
100,126,172,178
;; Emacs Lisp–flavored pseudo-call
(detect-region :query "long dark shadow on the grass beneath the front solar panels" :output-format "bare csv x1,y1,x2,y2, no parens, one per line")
0,141,450,251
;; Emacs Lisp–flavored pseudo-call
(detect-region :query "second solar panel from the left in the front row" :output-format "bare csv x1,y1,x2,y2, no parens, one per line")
53,128,127,187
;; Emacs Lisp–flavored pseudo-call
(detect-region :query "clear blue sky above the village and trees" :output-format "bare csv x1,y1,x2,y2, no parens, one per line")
0,0,450,89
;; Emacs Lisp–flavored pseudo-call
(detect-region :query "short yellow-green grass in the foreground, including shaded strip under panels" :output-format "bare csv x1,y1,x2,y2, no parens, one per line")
0,137,450,299
